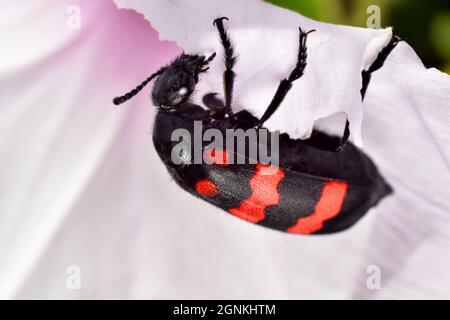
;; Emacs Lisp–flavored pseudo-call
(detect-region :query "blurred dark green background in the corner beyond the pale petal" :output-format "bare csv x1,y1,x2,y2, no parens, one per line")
267,0,450,73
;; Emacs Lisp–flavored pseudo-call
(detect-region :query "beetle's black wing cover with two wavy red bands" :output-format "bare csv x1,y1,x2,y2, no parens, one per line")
164,147,390,234
